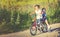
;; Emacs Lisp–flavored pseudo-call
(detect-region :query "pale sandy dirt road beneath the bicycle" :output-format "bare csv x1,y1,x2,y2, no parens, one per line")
0,23,60,37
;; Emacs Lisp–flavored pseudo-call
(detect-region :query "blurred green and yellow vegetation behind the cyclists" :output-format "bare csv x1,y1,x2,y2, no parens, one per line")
0,0,60,34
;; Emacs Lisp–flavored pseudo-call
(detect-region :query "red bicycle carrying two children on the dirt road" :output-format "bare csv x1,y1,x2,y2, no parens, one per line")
30,20,48,36
